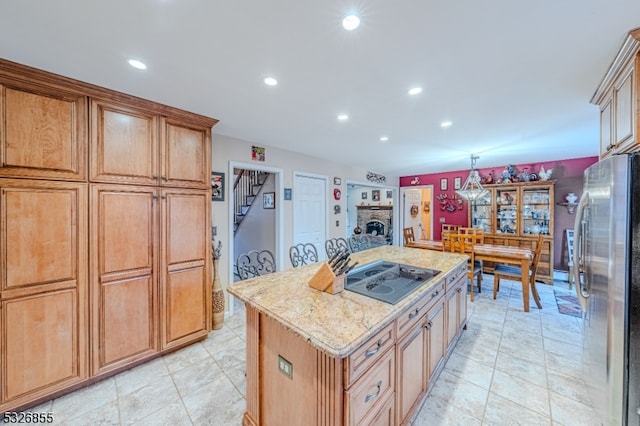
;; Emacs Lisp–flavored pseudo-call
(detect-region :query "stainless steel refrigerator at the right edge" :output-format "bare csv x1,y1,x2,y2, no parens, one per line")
571,154,640,426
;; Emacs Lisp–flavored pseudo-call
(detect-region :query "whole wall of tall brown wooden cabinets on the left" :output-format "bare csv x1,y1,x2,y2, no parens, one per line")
0,60,217,411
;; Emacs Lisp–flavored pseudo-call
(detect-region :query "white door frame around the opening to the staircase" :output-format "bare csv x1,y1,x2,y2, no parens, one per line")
227,161,284,315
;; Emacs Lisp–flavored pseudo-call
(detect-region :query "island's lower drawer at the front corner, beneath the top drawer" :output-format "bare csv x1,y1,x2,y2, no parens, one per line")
345,351,395,425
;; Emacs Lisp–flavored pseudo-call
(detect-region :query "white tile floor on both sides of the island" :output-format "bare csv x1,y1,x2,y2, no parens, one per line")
25,275,593,426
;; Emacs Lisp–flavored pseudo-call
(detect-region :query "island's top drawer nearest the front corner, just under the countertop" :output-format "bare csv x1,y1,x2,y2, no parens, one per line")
344,323,396,388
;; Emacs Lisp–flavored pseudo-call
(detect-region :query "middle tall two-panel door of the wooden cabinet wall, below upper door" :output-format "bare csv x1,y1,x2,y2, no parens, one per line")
91,184,158,374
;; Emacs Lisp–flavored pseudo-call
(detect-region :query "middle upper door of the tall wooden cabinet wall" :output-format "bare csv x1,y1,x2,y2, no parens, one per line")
91,100,158,185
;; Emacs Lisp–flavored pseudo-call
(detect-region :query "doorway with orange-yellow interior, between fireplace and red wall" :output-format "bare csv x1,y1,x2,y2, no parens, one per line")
400,185,433,240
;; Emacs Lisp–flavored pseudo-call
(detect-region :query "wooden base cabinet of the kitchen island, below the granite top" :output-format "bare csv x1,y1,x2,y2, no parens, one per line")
238,256,466,426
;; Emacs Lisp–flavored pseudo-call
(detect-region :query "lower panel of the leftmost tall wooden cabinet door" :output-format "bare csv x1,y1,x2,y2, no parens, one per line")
2,289,86,402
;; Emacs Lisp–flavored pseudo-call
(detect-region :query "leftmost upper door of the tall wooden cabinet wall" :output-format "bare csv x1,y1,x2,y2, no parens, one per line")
0,82,87,180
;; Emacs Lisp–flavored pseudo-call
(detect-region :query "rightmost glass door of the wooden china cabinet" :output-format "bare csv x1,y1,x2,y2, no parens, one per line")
520,188,553,235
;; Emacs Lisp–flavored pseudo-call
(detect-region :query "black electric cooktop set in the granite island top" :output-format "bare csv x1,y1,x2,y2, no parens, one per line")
344,260,440,305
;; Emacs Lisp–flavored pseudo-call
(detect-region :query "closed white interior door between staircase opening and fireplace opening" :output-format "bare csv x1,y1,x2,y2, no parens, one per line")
293,174,327,260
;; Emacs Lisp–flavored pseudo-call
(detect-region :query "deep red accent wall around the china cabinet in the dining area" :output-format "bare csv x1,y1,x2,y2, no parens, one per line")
400,157,598,270
